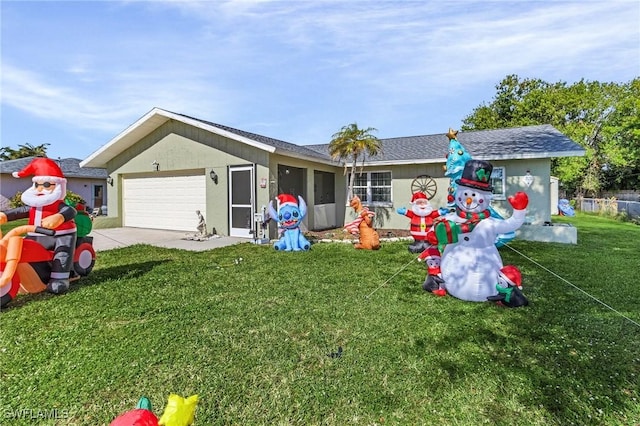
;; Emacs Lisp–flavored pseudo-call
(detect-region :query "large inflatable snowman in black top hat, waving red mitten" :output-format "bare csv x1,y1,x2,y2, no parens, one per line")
430,160,529,302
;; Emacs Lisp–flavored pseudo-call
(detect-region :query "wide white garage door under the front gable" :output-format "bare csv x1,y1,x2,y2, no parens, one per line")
122,175,206,233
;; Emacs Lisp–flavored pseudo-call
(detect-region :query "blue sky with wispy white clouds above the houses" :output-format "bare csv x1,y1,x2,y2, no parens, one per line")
0,0,640,159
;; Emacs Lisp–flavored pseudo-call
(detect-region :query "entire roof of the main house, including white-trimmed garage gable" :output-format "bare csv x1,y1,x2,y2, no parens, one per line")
80,108,585,167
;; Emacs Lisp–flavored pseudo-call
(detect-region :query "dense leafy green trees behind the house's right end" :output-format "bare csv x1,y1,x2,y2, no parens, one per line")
462,75,640,195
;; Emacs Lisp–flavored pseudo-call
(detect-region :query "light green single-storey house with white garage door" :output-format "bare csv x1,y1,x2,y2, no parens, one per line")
80,108,584,243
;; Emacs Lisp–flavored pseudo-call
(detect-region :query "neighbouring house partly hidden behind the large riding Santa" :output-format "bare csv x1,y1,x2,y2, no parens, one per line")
0,157,108,212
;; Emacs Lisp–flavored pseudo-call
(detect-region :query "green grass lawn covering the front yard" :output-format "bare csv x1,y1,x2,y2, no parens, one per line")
0,215,640,426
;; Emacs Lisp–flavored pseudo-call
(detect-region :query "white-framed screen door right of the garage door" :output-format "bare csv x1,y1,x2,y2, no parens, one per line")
229,166,254,238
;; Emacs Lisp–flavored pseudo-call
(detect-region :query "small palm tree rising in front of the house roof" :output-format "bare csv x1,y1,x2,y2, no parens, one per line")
329,123,382,200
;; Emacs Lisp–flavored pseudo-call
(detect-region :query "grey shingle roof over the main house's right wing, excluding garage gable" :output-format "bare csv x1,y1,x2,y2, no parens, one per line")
307,124,585,165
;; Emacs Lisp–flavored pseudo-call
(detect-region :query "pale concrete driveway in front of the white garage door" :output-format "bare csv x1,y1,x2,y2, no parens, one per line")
89,228,248,251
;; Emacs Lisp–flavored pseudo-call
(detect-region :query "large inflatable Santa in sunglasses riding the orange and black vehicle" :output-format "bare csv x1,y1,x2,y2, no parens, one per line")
0,158,76,293
